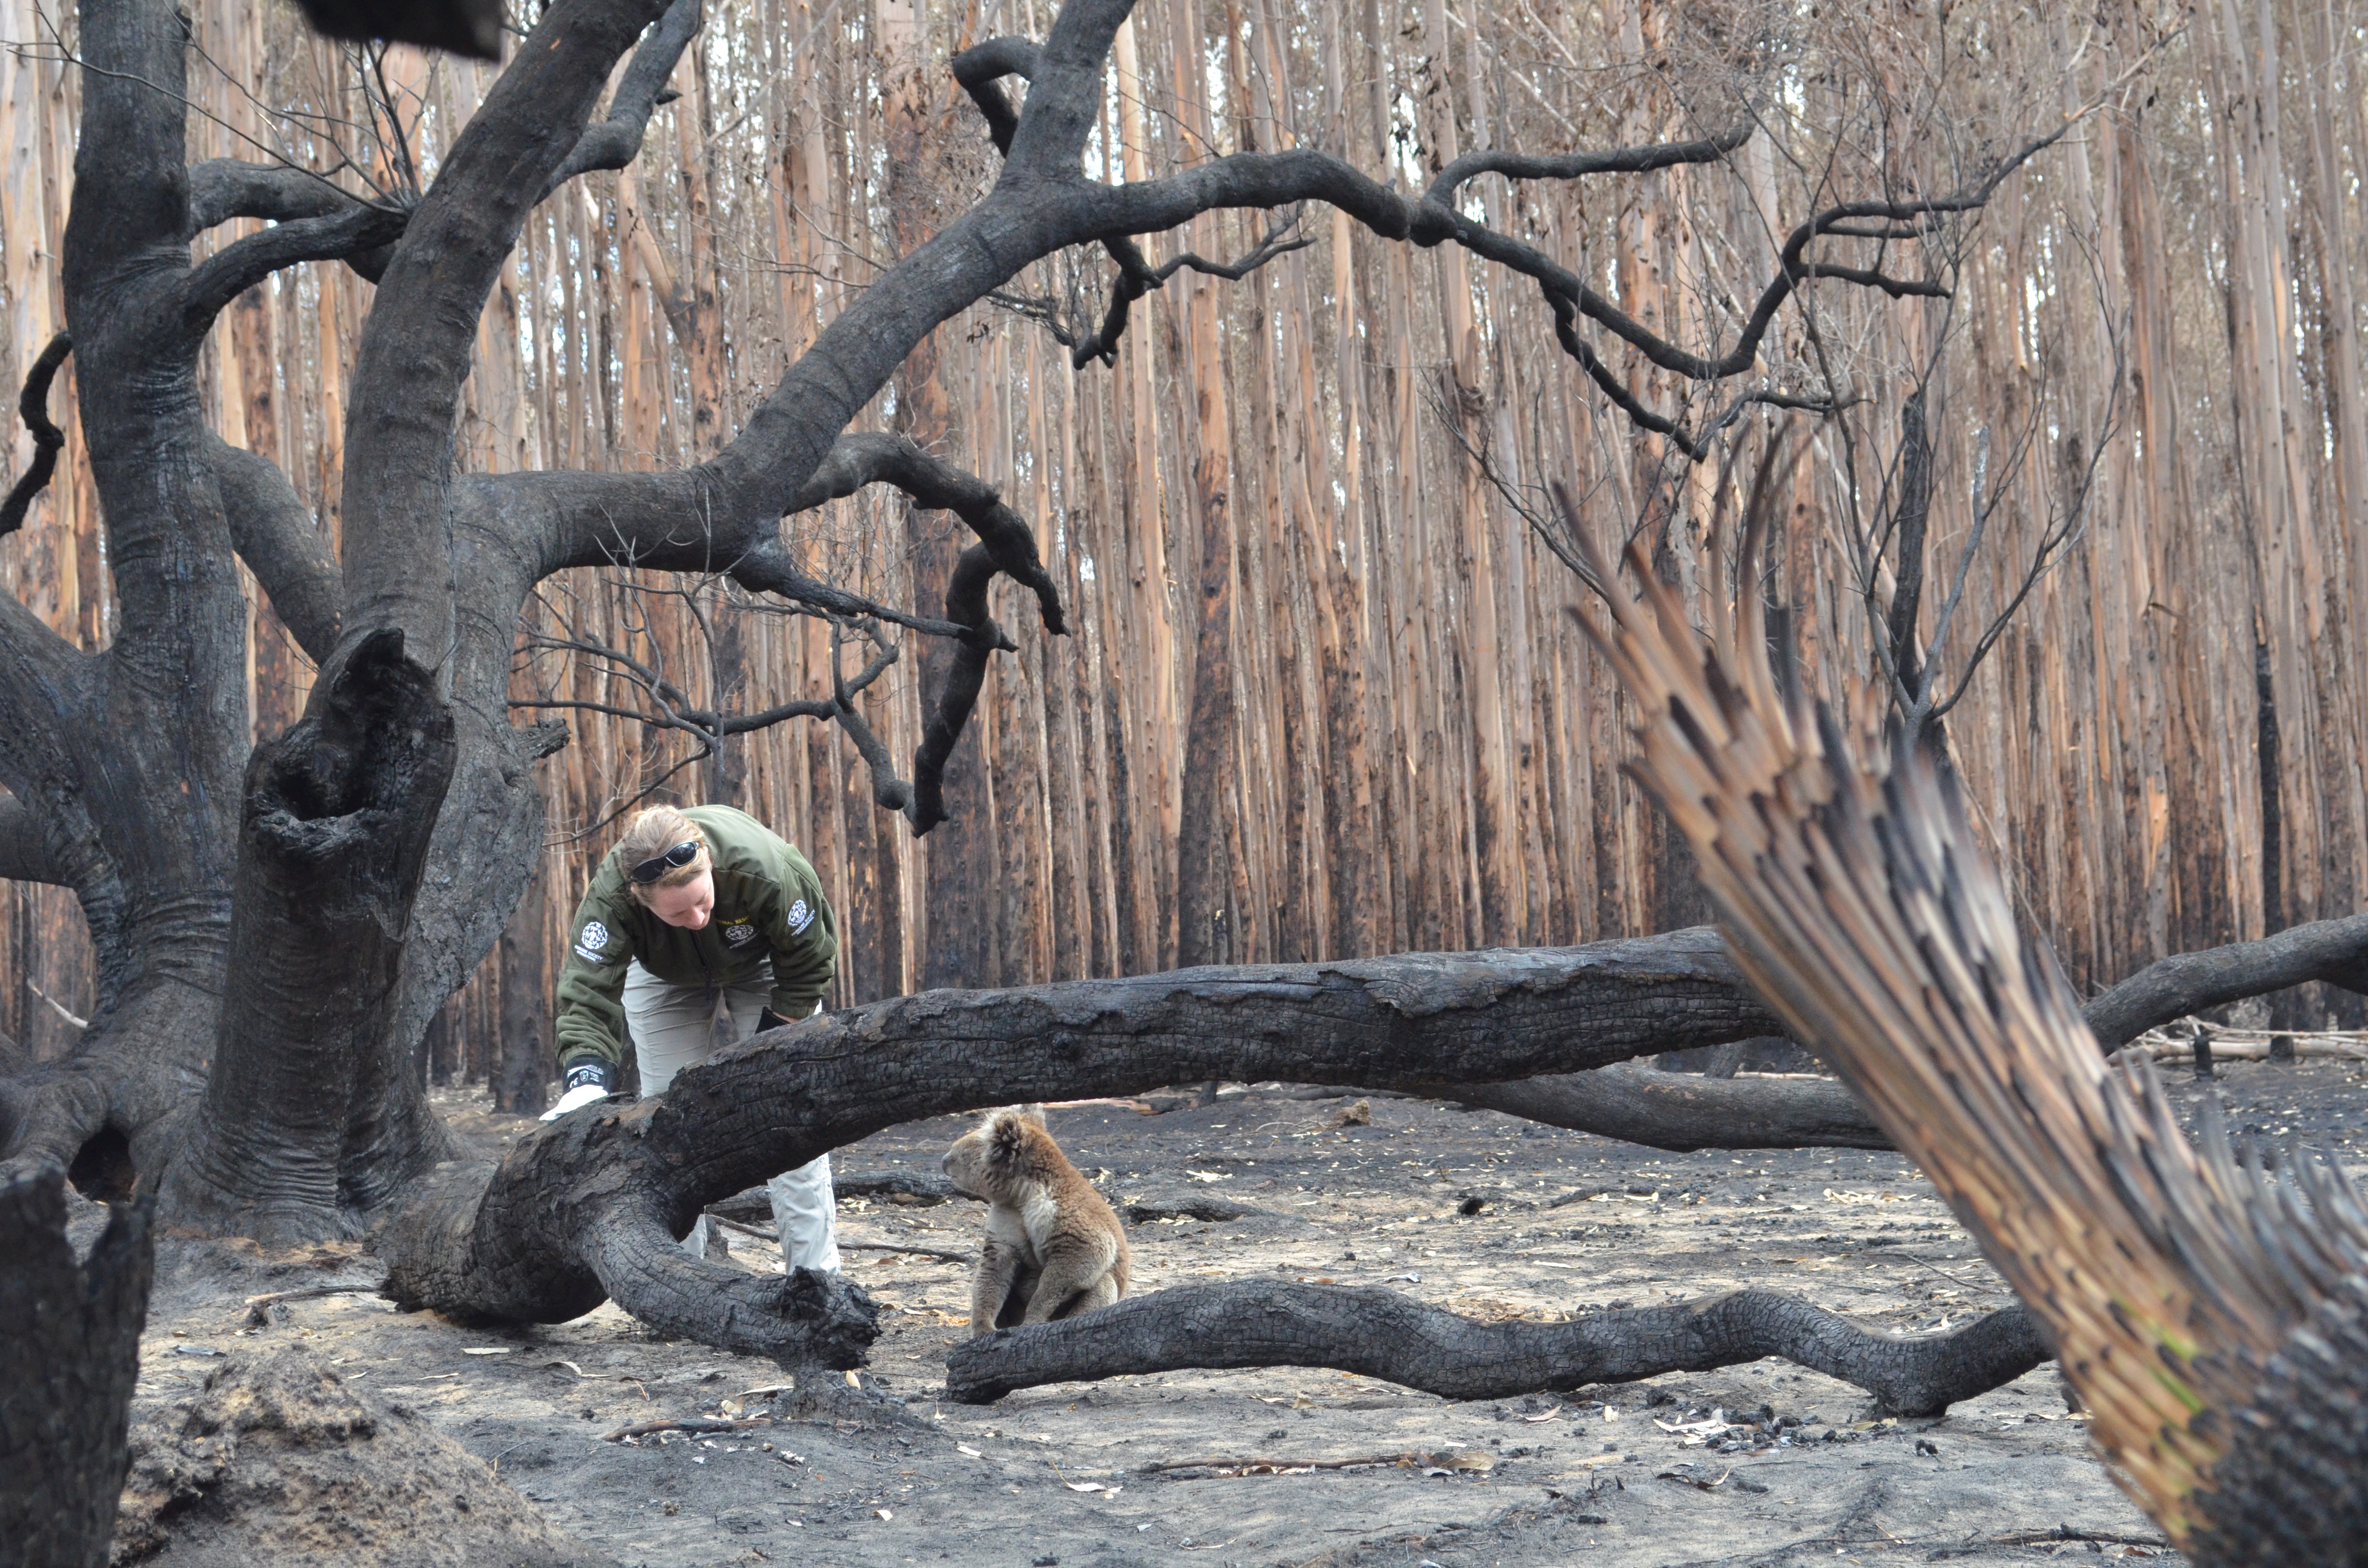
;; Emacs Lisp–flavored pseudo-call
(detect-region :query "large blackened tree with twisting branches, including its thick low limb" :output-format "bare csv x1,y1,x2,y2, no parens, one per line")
0,0,2358,1411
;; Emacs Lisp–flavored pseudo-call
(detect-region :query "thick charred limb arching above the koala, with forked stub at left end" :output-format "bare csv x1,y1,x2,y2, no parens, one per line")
377,929,1774,1367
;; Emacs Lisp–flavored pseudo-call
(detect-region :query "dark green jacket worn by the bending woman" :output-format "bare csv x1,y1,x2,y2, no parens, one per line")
554,805,839,1073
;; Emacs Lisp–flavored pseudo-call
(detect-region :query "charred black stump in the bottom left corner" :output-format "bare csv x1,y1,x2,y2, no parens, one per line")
0,1170,154,1568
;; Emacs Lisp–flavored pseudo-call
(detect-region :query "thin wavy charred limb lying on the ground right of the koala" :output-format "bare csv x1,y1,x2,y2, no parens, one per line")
945,1281,2056,1416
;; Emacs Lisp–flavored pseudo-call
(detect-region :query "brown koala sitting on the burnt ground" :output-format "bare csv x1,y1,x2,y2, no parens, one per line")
945,1111,1127,1338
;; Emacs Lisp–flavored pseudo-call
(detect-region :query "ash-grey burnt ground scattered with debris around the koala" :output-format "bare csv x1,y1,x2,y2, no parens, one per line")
92,1061,2368,1568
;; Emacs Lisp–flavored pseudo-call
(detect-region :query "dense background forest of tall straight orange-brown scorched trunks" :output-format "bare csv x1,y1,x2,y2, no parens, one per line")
0,0,2368,1078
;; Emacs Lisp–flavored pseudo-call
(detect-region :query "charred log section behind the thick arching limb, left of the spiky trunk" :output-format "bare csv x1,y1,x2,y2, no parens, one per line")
1456,1061,1892,1153
